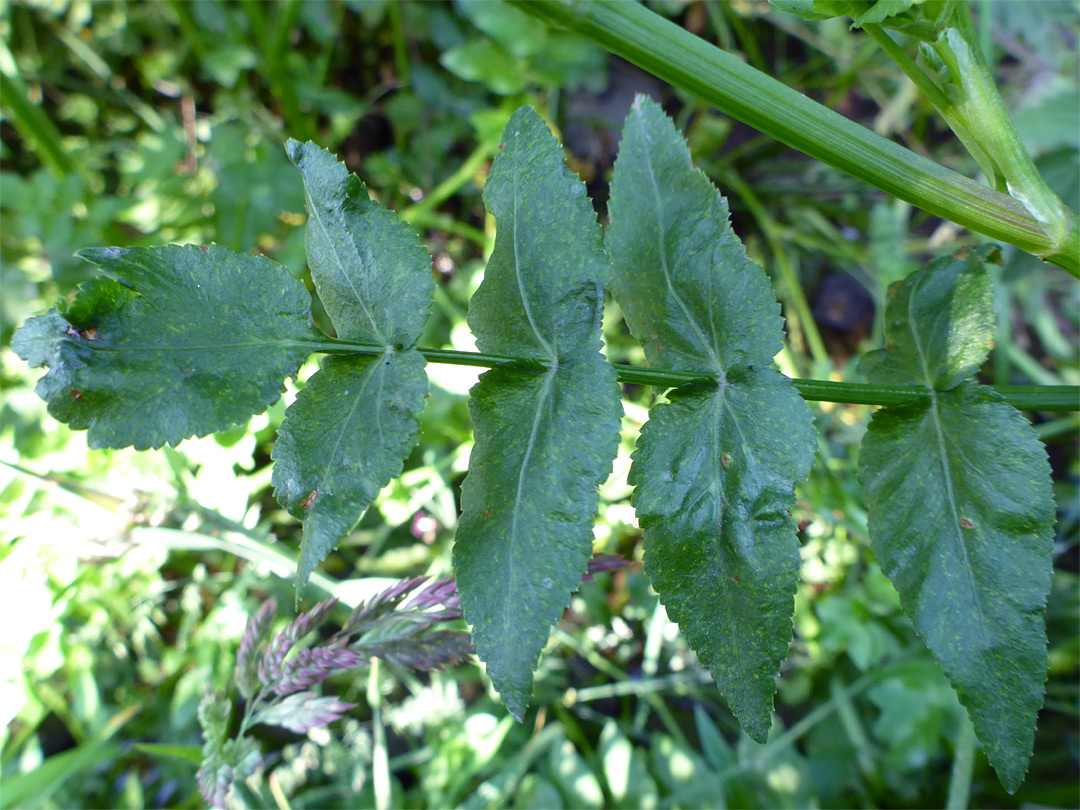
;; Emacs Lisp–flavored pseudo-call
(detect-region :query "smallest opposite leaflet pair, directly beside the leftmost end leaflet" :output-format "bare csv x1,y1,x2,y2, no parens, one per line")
273,140,434,599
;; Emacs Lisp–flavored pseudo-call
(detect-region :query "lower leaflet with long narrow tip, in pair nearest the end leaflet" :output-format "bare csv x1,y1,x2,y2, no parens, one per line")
272,350,428,596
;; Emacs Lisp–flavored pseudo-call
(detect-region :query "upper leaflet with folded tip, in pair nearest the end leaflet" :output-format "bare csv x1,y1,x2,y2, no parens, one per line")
285,140,434,348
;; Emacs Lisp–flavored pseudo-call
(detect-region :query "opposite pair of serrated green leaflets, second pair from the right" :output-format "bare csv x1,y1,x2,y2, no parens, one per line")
606,96,815,741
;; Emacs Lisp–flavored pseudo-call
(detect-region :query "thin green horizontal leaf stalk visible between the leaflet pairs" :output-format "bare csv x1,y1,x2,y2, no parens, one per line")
308,338,1080,410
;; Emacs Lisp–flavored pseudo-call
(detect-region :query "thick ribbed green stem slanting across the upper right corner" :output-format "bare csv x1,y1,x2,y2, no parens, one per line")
510,0,1080,276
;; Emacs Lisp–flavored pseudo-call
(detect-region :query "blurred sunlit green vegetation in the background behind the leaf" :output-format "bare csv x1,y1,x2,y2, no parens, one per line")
0,0,1080,808
